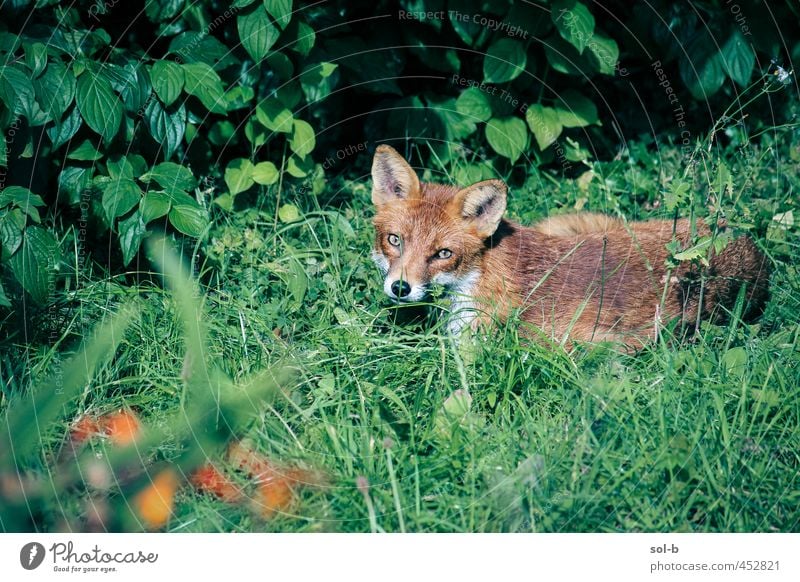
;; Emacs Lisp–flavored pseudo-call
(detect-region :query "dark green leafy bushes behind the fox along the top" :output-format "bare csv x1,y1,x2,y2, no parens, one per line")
0,0,790,303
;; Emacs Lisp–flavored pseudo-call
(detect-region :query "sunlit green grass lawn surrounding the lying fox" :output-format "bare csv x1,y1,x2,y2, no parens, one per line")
2,130,800,532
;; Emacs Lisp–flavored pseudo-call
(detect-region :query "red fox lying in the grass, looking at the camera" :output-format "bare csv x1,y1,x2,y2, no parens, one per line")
372,145,769,348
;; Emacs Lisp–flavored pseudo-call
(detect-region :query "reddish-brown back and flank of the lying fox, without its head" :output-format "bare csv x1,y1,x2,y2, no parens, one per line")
482,218,768,343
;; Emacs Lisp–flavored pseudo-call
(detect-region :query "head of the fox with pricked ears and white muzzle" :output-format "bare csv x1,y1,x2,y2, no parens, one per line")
372,145,506,302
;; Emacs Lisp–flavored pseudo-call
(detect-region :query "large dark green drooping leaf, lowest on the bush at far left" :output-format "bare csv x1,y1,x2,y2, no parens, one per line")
9,226,59,305
